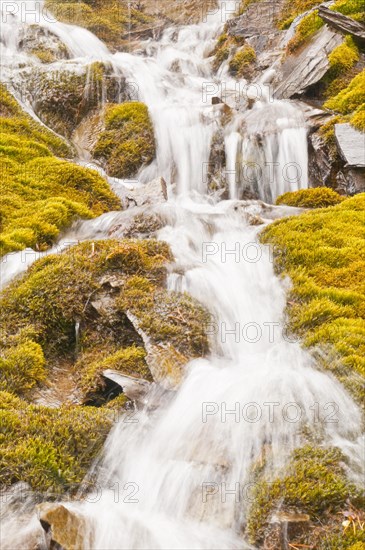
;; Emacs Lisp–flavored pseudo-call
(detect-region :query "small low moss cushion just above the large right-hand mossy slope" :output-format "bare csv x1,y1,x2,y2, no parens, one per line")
276,187,344,208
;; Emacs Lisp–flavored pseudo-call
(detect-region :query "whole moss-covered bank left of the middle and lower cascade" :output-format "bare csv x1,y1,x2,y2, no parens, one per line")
0,239,208,491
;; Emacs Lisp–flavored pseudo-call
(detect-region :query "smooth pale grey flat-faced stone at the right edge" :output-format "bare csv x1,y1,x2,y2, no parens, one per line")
335,124,365,168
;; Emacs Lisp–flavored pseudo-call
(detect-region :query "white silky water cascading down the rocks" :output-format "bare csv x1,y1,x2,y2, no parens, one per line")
2,2,362,550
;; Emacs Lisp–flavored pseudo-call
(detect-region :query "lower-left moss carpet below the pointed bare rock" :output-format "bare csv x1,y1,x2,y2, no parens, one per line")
0,392,113,498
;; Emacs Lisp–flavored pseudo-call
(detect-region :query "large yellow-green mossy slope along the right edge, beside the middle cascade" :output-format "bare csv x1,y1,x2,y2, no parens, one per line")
262,194,365,401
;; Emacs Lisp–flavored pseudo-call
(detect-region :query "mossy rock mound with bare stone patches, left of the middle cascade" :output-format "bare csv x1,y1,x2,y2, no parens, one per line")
0,239,208,397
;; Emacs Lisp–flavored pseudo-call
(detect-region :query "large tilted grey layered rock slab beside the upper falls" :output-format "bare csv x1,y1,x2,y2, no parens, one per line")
274,26,343,99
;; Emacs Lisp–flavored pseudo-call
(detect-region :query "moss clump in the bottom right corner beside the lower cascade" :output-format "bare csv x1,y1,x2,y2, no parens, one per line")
247,445,362,547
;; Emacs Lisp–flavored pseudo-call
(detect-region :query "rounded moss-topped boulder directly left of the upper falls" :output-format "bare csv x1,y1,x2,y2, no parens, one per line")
93,102,156,178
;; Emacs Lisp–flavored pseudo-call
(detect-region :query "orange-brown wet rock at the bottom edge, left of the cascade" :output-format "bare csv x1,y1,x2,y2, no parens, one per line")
37,503,88,550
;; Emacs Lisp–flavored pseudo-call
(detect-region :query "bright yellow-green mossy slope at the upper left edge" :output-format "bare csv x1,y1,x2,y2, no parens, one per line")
0,86,120,255
